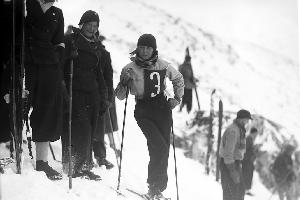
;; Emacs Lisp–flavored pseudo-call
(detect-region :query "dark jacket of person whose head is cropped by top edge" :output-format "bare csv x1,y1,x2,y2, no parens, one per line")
25,0,64,65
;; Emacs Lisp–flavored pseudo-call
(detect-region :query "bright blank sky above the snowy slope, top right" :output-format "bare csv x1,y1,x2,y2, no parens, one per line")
145,0,299,61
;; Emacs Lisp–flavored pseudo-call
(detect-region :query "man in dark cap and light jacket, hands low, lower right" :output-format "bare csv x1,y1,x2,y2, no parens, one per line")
219,110,252,200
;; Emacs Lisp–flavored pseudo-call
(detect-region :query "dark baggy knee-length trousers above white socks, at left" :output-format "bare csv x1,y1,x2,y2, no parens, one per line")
26,64,63,142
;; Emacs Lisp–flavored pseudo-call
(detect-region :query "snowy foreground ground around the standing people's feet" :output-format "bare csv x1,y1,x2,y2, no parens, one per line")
0,108,277,200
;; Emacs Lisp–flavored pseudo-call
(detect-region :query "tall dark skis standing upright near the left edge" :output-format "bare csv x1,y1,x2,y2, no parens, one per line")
10,0,25,174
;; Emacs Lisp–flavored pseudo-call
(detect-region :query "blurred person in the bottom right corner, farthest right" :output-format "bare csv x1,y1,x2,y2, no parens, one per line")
272,144,296,200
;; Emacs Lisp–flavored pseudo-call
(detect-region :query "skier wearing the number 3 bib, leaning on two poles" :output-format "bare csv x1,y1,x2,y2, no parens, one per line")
115,34,184,199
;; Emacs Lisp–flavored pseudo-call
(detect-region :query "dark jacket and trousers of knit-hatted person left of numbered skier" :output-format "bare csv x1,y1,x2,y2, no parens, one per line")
62,29,108,173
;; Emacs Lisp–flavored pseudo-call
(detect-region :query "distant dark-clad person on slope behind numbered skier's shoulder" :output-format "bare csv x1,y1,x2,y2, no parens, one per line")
178,47,196,113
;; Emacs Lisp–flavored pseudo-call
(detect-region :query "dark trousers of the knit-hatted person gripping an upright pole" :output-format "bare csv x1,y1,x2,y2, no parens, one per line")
62,91,100,173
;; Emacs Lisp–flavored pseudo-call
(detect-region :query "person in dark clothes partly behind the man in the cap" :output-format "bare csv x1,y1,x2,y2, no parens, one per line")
242,127,257,195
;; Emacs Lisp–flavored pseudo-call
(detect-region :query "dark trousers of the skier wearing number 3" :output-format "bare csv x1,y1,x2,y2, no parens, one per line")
134,95,172,192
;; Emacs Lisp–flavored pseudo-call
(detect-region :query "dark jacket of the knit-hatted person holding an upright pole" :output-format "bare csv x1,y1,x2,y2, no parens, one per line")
64,29,108,111
